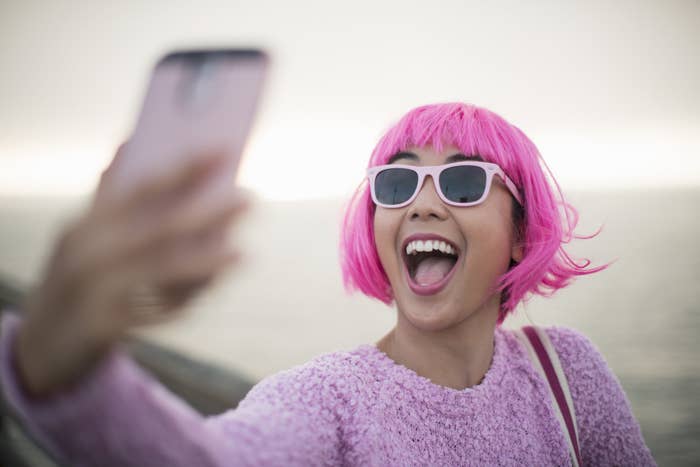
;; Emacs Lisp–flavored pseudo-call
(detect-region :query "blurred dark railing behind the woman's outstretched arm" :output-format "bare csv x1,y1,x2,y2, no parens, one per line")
0,276,254,467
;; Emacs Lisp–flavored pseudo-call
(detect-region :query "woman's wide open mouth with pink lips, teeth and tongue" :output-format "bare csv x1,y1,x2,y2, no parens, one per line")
402,238,460,295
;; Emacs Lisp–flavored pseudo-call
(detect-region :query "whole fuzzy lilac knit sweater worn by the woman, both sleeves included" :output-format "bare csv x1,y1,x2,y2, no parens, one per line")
0,313,656,467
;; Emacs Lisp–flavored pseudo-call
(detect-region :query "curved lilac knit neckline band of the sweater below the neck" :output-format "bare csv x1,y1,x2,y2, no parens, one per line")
360,327,507,410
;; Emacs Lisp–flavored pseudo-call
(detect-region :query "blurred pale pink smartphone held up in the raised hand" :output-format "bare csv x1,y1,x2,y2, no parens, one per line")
102,49,269,210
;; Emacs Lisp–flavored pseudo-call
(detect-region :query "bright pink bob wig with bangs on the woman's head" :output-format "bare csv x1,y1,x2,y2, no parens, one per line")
340,103,608,325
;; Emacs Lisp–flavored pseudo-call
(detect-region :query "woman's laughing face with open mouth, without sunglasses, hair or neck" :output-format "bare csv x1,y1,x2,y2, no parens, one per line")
374,146,522,331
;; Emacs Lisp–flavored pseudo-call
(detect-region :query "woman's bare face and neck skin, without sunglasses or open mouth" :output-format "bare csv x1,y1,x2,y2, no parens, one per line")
374,146,522,390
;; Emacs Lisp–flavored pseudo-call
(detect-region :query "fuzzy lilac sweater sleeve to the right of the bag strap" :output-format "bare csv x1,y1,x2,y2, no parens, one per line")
546,326,656,466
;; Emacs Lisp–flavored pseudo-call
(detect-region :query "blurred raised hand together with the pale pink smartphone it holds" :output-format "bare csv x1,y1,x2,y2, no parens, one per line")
14,48,264,397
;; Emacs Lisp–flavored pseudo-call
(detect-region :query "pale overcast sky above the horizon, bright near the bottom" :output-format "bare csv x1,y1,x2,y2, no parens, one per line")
0,0,700,200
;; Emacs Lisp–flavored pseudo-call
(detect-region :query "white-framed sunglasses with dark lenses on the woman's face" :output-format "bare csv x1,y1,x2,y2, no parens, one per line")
367,161,523,208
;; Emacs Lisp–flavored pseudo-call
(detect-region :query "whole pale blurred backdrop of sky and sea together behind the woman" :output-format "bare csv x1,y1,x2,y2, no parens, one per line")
0,0,700,465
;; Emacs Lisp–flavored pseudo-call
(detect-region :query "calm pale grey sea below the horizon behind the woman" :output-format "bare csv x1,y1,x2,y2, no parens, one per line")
0,188,700,466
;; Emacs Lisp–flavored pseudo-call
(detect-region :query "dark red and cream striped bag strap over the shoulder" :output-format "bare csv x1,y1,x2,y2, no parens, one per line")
514,326,582,467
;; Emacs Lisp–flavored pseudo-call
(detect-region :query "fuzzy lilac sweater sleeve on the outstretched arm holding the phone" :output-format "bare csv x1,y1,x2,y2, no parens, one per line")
0,313,339,467
